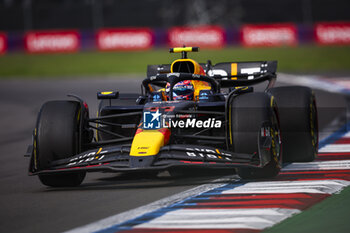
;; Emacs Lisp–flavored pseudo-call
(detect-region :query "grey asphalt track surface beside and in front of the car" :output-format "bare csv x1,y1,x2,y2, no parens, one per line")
0,77,346,233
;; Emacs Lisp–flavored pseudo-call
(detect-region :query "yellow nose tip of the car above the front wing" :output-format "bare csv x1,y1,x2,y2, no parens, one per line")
130,130,164,156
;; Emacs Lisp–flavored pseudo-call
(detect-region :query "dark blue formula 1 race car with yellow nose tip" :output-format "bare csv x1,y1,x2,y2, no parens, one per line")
27,47,318,187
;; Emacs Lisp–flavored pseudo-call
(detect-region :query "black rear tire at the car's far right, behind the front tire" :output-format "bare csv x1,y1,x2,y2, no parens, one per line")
268,86,318,162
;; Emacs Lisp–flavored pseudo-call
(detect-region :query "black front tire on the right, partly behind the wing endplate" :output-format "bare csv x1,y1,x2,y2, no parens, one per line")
230,92,281,179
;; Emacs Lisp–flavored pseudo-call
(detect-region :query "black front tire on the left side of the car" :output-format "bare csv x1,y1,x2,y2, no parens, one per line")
35,101,86,187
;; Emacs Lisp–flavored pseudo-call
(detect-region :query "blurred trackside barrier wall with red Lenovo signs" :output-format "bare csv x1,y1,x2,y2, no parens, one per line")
0,22,350,54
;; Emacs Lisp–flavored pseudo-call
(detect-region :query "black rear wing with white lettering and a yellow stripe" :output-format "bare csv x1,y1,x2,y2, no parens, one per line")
147,61,277,87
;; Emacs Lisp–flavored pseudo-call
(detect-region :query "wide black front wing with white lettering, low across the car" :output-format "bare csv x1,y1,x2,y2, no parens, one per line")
29,144,270,175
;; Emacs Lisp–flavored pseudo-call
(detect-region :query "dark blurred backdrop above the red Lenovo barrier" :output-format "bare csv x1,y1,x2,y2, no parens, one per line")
0,0,350,31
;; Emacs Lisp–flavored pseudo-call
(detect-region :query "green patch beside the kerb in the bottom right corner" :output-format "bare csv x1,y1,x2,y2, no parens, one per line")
264,187,350,233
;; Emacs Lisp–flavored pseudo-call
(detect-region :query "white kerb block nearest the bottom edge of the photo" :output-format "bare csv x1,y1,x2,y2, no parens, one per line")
134,208,300,229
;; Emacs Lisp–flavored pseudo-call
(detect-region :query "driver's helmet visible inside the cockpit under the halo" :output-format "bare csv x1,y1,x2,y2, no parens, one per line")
166,80,194,100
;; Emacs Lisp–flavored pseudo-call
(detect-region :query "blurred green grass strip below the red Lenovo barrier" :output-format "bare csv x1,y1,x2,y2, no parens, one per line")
0,46,350,77
